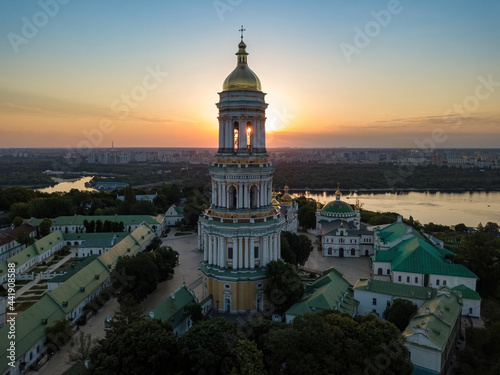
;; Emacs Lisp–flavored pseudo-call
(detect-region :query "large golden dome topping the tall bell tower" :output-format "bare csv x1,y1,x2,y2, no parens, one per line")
222,40,262,91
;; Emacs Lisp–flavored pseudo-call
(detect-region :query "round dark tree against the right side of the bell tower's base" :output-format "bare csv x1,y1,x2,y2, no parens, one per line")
266,260,305,311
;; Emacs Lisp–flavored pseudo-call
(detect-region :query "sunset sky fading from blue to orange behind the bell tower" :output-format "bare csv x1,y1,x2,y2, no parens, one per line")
0,0,500,149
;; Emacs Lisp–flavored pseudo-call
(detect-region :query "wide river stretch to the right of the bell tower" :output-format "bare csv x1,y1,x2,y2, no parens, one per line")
293,191,500,227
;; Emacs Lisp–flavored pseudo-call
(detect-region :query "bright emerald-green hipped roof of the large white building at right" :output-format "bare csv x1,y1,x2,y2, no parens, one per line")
373,236,477,279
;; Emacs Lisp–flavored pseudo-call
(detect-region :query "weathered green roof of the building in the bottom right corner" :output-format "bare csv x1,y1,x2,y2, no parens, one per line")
403,293,462,352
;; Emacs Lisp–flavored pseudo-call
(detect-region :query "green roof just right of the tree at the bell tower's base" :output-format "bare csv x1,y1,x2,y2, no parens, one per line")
285,268,359,316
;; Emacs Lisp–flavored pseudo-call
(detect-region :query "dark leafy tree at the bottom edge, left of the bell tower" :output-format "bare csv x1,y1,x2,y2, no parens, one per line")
88,319,180,375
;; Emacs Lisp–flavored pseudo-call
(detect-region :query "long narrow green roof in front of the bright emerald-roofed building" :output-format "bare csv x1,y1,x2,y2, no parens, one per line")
354,279,437,300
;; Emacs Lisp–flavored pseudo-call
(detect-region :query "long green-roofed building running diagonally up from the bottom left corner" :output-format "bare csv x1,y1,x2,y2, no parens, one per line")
0,225,156,375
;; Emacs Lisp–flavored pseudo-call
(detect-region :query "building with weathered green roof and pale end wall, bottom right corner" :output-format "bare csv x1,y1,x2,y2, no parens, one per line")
403,291,462,375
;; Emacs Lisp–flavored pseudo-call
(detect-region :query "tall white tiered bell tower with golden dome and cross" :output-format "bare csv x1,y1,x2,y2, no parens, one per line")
198,27,285,314
